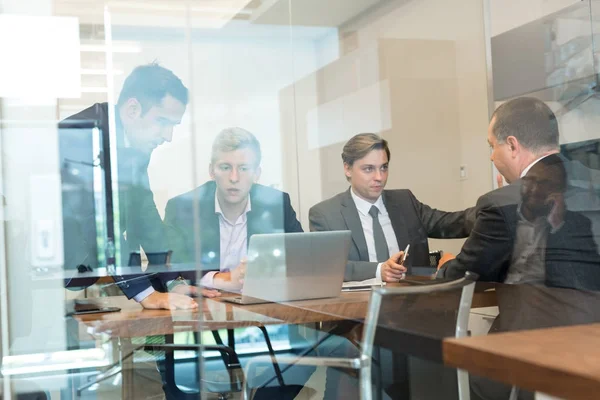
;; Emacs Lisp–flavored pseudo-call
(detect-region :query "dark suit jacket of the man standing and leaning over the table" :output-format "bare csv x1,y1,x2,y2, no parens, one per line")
59,103,172,298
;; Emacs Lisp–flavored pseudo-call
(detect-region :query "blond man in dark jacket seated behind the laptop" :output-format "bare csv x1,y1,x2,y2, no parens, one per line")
165,128,302,288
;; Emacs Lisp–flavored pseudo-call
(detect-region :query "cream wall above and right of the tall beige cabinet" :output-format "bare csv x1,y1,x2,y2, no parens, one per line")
344,0,491,212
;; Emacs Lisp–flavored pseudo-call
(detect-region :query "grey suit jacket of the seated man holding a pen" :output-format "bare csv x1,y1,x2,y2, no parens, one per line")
309,189,474,281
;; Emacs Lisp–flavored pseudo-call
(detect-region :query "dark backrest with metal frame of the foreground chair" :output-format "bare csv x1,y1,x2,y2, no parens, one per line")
361,272,478,362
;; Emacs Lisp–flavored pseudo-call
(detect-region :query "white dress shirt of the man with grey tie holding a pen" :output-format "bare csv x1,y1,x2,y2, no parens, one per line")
350,189,400,281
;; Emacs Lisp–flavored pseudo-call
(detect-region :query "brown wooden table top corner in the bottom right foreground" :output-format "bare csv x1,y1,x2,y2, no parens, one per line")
443,323,600,399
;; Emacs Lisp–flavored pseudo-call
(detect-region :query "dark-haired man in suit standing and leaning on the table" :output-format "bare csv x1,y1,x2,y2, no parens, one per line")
59,64,216,309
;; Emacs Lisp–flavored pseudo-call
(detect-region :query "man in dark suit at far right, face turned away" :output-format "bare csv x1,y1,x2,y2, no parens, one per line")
437,97,600,290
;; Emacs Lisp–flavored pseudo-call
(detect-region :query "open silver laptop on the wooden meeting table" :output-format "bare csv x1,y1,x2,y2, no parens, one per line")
223,231,351,304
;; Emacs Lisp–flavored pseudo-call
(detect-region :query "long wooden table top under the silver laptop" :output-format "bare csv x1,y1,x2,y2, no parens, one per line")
75,278,496,337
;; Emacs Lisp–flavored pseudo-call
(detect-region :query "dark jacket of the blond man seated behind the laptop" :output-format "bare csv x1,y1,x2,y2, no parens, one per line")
164,181,303,271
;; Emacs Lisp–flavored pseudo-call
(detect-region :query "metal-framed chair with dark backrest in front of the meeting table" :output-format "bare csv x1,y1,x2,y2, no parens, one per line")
243,272,478,400
